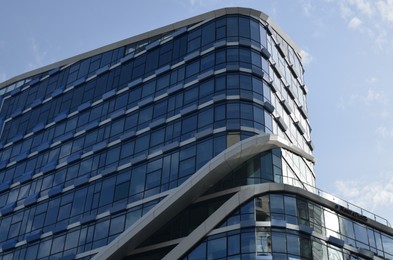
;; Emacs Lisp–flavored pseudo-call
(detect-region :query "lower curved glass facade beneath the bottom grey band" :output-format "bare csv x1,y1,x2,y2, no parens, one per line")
185,193,393,259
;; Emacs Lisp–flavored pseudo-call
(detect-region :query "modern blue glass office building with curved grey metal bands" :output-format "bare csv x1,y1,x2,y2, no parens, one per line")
0,8,393,260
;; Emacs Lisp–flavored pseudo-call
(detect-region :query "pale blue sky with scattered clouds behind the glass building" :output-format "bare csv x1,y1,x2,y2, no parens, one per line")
0,0,393,223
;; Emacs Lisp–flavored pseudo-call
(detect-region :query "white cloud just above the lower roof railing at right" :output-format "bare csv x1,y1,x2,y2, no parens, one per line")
335,173,393,210
